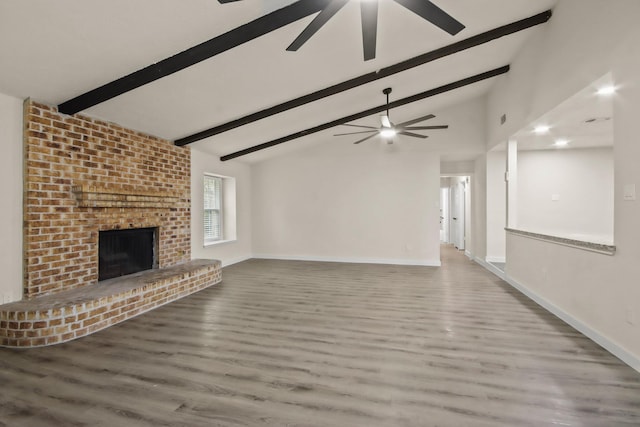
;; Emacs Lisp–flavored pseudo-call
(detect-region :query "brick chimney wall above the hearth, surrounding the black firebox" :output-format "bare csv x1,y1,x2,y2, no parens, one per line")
24,100,191,299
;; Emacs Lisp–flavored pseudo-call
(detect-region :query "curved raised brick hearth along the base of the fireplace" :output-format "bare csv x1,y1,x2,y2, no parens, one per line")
0,260,222,347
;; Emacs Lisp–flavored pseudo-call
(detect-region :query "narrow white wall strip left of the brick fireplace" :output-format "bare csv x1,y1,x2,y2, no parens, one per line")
0,94,23,304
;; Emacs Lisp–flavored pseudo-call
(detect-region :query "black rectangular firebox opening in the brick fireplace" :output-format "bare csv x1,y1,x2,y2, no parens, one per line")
98,228,158,281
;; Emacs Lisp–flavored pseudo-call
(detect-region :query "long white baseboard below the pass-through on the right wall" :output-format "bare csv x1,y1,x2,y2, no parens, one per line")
475,258,640,372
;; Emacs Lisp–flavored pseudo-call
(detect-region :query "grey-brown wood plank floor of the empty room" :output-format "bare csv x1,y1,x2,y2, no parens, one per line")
0,246,640,427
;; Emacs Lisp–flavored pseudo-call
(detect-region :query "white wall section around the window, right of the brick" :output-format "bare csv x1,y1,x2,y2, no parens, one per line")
191,148,252,266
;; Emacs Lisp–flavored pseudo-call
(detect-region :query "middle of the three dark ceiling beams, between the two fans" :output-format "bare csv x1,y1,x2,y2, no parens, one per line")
175,10,551,146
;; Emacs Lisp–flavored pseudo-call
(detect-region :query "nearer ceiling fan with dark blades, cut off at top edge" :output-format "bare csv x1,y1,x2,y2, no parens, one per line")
218,0,465,61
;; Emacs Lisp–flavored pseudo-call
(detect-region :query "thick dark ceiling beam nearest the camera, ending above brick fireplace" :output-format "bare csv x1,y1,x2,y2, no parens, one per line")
58,0,330,114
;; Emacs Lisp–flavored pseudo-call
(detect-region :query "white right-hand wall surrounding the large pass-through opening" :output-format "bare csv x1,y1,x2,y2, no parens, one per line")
487,0,640,370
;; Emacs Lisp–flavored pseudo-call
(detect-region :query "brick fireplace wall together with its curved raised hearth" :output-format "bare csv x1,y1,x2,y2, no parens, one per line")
0,100,221,346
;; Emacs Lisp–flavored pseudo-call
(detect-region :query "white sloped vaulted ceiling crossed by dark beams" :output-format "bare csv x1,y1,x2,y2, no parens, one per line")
0,0,556,162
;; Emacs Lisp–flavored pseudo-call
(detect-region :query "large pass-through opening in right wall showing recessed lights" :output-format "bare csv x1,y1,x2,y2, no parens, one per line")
508,74,615,244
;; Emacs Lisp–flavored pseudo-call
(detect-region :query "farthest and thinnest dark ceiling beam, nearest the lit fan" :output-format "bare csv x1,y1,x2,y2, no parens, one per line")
220,65,509,162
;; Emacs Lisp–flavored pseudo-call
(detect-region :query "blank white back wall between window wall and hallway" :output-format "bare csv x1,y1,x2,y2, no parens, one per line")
252,140,440,265
